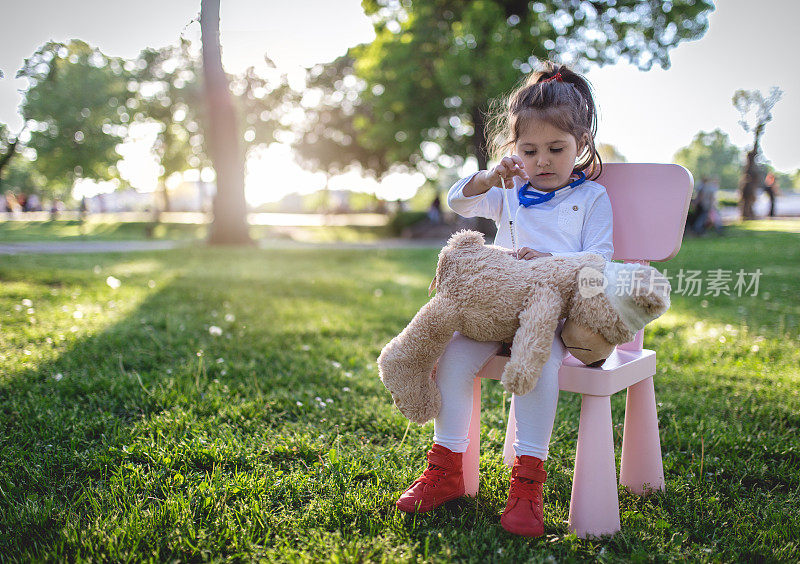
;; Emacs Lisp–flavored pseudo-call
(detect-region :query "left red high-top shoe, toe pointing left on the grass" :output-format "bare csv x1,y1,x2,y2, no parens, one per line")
395,443,464,513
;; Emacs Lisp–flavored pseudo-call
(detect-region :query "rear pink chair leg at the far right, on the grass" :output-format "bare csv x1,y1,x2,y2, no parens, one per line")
619,376,664,495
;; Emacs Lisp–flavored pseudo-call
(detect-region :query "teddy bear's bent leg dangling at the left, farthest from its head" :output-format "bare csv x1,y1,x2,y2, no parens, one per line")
378,296,457,424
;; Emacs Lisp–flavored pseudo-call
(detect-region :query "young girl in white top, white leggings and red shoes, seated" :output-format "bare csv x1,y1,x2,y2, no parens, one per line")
397,62,614,536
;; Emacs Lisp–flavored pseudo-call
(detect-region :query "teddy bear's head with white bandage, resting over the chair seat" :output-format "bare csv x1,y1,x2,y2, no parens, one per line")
561,261,670,366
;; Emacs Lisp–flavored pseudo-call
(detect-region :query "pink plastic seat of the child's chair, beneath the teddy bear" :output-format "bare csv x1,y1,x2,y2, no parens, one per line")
478,348,656,396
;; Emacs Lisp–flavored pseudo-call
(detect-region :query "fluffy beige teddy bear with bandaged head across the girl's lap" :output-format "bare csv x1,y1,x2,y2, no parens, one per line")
378,230,670,424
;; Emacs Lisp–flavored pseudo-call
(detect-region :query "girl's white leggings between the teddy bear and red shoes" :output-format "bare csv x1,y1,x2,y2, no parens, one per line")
433,324,565,460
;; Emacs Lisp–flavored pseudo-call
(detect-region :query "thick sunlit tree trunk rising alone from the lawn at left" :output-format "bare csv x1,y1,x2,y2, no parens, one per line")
200,0,253,245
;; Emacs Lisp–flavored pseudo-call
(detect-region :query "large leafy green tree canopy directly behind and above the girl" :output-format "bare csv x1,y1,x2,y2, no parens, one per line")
296,0,713,178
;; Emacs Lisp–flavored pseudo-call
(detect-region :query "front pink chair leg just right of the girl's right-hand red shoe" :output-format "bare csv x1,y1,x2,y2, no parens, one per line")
569,394,620,538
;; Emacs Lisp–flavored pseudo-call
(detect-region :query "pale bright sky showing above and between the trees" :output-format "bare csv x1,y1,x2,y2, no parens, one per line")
0,0,800,204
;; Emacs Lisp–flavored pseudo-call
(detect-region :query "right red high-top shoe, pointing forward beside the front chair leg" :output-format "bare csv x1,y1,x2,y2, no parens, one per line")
500,454,547,537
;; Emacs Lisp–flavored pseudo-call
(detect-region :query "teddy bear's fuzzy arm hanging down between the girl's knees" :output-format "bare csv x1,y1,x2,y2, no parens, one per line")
500,288,561,396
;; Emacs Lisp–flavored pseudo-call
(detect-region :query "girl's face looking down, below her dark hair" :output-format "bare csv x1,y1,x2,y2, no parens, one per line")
514,117,583,192
